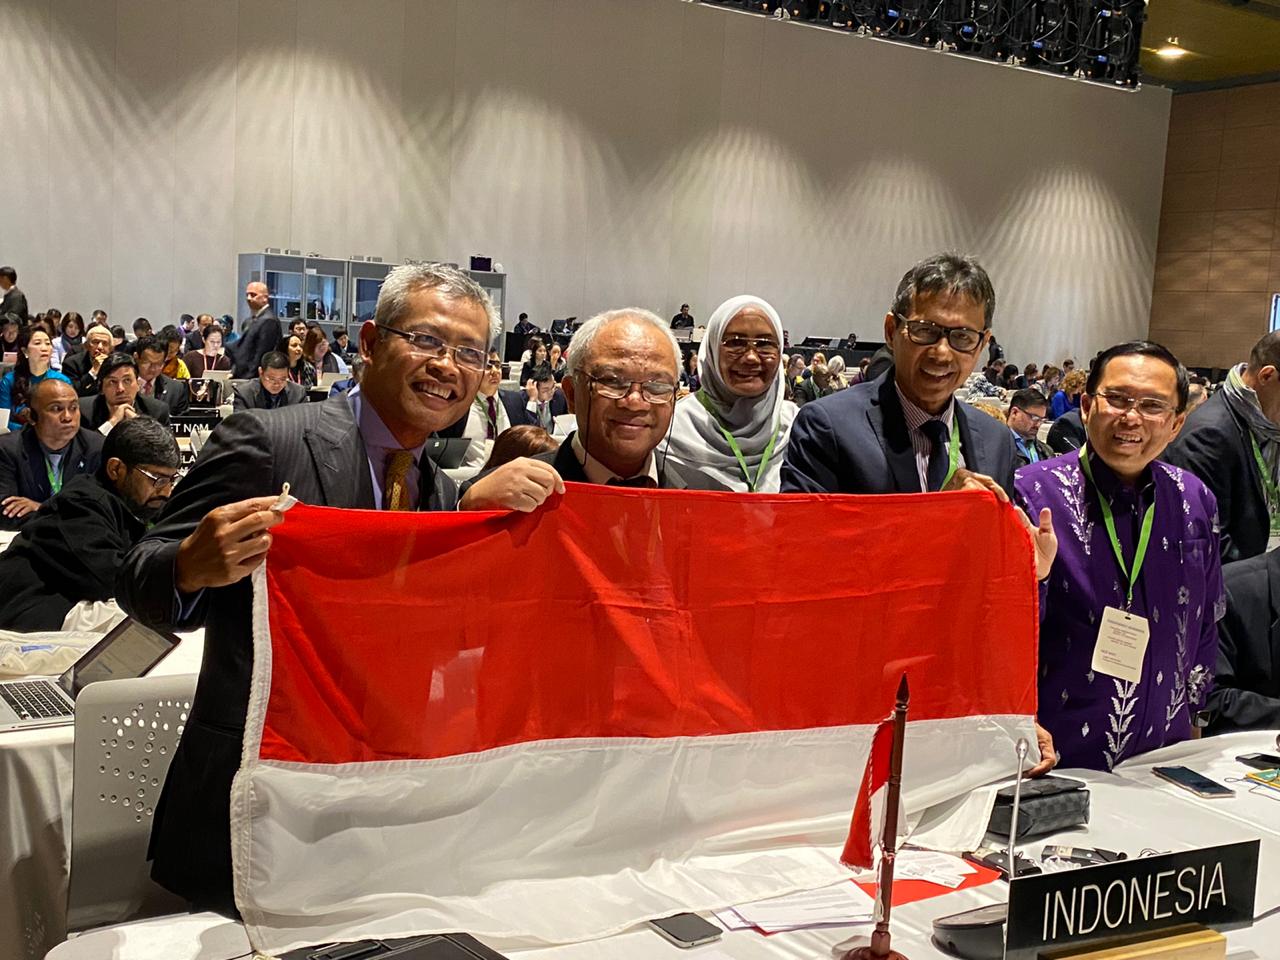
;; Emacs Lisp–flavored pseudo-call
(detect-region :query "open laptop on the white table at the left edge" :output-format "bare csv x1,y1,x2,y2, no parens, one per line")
0,617,178,731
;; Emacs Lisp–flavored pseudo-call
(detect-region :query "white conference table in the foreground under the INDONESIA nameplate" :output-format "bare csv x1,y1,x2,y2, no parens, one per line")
40,731,1280,960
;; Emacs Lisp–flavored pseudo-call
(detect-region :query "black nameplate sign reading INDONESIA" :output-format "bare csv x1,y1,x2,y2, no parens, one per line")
1005,840,1261,960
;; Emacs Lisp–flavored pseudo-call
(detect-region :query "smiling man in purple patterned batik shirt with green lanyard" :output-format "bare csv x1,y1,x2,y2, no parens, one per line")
1015,342,1225,769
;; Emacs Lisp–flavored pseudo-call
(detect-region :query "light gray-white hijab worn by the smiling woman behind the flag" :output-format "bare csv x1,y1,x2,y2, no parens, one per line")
667,296,797,493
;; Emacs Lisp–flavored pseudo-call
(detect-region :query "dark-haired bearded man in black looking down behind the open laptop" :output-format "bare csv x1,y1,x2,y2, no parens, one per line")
0,417,179,631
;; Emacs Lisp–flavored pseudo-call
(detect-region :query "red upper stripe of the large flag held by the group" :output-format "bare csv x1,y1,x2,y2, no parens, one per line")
260,484,1037,763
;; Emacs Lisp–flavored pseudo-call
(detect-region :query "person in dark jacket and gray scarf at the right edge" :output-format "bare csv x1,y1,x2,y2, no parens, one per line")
1164,333,1280,563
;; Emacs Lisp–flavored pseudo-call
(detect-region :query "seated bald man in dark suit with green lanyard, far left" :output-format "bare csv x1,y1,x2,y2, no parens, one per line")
0,379,102,530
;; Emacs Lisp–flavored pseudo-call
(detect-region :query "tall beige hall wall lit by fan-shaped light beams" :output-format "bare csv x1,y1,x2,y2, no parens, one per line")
0,0,1169,362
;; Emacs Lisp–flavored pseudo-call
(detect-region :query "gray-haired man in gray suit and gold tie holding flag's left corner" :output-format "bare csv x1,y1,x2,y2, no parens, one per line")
118,264,502,915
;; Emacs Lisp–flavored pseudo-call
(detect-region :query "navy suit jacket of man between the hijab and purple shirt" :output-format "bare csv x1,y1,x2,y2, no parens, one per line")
782,370,1015,495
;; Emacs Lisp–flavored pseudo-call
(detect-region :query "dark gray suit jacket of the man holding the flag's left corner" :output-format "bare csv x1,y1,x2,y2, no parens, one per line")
116,396,457,915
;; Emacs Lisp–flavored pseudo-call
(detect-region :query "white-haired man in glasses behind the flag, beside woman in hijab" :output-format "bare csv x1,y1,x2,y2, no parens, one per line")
461,307,714,512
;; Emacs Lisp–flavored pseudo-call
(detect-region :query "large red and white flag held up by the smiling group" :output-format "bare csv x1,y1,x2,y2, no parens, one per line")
232,484,1037,954
